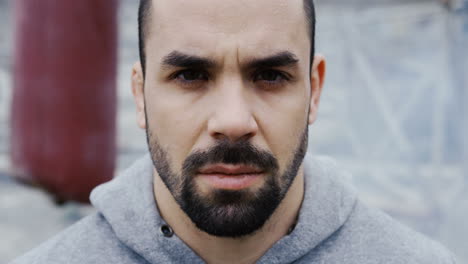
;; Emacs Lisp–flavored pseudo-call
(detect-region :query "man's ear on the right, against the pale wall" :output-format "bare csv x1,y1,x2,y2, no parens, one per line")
309,54,326,125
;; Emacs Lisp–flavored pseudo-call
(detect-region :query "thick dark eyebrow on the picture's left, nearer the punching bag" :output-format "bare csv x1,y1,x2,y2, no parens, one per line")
161,51,216,69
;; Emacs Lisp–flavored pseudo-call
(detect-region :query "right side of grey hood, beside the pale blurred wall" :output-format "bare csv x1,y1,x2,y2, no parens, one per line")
257,157,356,263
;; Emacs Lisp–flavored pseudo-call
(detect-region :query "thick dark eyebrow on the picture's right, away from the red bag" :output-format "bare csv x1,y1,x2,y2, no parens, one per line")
246,51,299,69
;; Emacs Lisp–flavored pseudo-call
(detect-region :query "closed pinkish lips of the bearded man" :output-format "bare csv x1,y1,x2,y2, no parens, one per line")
198,164,263,190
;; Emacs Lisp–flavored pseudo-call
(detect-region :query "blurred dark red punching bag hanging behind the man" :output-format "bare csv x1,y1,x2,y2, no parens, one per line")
11,0,118,202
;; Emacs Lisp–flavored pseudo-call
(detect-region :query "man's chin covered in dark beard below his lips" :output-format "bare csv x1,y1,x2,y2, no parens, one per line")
181,177,281,238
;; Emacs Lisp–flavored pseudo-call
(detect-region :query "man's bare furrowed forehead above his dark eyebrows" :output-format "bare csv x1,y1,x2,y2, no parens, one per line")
147,0,310,60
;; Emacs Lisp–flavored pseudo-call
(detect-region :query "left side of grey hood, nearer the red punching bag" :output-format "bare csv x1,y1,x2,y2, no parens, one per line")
90,155,203,264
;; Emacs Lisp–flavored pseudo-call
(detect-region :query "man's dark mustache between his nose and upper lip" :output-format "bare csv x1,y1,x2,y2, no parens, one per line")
182,141,279,175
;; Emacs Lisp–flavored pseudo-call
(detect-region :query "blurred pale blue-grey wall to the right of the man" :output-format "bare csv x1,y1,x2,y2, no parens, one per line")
310,0,468,263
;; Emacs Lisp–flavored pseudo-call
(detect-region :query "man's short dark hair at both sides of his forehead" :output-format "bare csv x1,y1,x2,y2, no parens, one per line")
138,0,316,77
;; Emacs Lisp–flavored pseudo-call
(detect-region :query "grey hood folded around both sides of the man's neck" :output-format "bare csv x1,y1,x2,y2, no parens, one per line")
90,155,356,264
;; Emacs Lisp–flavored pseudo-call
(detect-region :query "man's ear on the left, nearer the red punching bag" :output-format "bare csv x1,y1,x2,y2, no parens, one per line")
132,62,146,129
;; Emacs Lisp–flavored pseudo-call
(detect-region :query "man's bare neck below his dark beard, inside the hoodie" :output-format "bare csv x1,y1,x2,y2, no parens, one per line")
154,168,304,263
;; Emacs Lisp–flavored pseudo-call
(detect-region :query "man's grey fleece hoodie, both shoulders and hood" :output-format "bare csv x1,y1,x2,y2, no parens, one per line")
12,156,455,264
